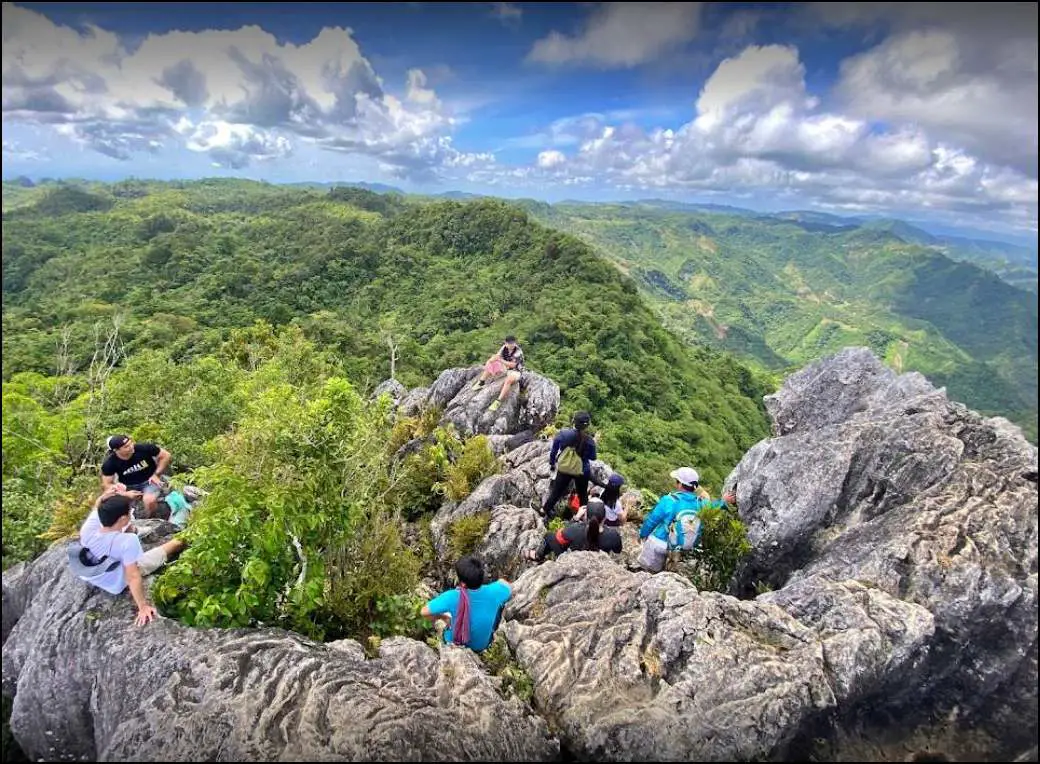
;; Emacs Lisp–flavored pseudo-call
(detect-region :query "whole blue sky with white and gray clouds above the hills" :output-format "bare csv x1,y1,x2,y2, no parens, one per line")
3,2,1037,241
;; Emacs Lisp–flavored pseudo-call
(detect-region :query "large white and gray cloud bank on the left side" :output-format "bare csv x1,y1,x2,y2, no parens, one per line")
3,3,487,176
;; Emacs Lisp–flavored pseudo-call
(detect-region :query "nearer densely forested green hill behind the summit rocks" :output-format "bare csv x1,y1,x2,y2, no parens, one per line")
3,180,768,505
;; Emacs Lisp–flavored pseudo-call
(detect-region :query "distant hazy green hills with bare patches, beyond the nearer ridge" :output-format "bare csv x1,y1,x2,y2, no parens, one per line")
524,203,1037,441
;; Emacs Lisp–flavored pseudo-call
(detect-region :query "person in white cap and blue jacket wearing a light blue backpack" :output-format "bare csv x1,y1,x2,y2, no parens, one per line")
639,467,735,573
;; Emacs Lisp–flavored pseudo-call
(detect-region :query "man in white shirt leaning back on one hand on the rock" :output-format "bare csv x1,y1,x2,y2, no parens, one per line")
75,488,184,626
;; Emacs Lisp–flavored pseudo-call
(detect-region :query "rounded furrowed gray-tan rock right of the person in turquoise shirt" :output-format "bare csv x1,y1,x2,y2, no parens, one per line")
502,552,835,761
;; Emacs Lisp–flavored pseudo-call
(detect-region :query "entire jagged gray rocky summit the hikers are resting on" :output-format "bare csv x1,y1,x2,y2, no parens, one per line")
3,348,1038,761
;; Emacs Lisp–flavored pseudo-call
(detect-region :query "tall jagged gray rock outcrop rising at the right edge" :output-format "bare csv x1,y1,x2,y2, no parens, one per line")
726,349,1037,757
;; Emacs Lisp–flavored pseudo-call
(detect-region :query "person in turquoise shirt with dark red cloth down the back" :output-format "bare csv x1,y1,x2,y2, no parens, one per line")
421,555,513,653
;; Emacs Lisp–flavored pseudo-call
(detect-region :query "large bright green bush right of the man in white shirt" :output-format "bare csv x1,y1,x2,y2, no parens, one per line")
154,337,420,639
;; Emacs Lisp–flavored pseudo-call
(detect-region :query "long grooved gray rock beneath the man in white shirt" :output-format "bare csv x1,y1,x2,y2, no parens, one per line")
3,545,560,761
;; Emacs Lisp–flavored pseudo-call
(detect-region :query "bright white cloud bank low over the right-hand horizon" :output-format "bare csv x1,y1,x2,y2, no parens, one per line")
495,45,1037,230
